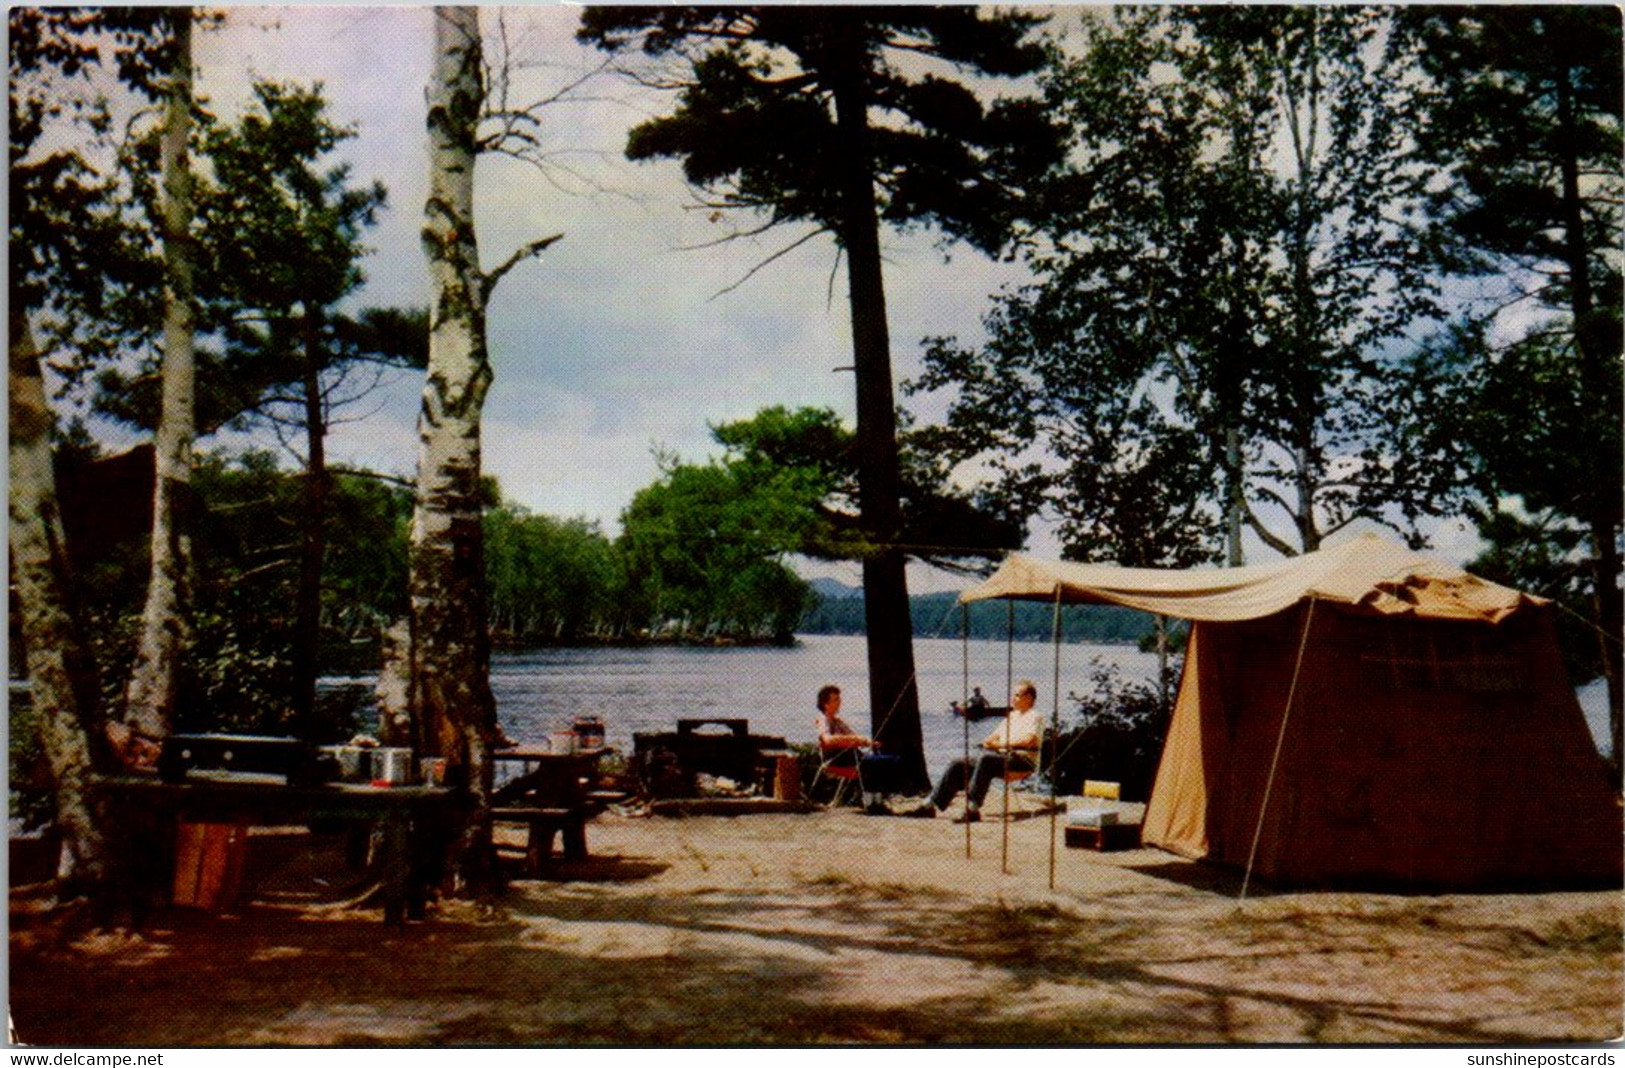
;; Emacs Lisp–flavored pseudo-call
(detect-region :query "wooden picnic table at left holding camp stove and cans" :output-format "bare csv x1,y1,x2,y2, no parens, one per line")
96,771,458,925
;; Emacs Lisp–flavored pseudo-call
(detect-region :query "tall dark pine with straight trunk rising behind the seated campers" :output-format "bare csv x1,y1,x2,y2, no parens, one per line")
580,7,1058,785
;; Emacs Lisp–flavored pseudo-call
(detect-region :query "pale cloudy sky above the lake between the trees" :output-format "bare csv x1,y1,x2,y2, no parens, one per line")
177,7,1040,590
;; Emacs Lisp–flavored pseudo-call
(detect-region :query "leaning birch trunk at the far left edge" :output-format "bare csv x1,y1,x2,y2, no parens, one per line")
8,310,114,889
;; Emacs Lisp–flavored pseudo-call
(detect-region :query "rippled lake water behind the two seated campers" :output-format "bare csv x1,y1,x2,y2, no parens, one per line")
491,634,1157,774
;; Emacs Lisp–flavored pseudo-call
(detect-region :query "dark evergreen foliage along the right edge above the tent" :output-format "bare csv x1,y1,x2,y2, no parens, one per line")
1399,5,1625,715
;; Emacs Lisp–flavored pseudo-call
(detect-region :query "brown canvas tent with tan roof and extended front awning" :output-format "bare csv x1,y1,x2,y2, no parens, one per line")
960,535,1625,889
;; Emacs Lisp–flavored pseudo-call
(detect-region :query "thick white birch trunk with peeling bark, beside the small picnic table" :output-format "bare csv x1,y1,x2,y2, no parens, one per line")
410,7,497,888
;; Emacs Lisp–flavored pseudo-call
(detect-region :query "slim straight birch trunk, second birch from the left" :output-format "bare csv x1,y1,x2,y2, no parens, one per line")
125,8,195,762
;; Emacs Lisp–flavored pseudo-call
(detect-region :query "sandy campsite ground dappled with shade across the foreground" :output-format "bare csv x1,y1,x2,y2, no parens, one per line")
10,811,1625,1047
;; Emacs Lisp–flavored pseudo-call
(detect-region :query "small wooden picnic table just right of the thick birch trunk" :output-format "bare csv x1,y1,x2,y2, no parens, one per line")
491,746,627,875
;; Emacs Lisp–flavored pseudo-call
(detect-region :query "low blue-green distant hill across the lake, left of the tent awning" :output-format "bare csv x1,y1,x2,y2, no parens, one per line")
796,579,1152,644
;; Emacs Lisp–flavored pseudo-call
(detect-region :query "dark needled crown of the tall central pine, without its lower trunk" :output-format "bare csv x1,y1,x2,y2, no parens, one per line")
579,5,1056,250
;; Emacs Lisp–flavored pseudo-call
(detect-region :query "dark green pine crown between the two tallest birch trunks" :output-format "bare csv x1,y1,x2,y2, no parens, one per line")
94,81,416,434
